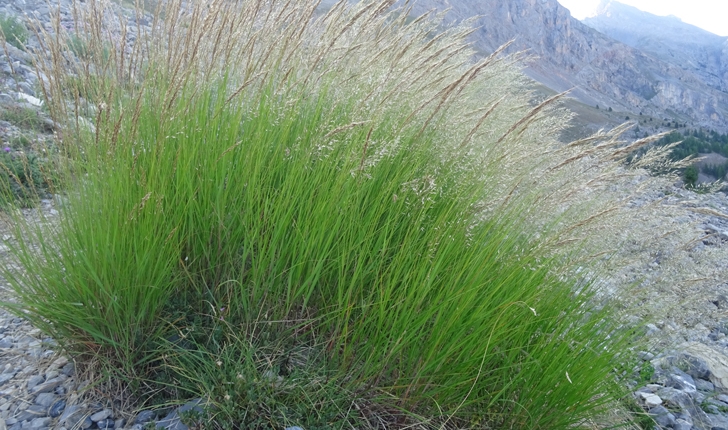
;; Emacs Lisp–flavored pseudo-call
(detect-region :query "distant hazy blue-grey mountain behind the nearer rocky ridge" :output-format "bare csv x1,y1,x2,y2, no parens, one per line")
583,0,728,91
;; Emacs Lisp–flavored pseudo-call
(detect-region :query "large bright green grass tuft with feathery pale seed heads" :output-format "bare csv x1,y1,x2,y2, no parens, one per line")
1,0,684,429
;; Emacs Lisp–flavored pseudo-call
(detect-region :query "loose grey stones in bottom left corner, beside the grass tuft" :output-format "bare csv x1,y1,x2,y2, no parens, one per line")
0,296,204,430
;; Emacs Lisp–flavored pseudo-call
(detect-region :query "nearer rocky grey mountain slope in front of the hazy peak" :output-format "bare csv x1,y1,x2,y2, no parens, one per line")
390,0,728,131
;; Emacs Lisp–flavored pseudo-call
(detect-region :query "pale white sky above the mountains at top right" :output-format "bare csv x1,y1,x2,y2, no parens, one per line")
558,0,728,36
